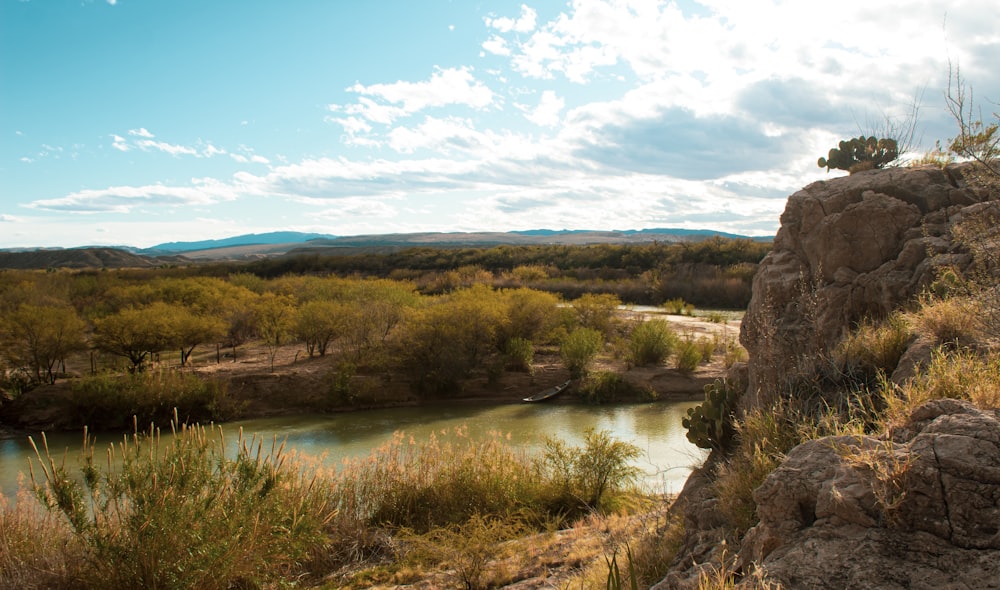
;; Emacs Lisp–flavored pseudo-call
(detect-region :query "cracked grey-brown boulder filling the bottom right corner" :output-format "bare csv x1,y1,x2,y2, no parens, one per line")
739,400,1000,589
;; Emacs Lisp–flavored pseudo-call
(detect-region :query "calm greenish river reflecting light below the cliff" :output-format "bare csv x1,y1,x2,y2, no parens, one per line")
0,401,707,496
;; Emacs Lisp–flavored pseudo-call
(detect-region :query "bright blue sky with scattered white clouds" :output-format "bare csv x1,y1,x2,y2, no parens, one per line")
0,0,1000,248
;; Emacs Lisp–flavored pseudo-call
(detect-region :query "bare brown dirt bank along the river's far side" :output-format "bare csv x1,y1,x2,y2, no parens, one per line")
0,310,739,437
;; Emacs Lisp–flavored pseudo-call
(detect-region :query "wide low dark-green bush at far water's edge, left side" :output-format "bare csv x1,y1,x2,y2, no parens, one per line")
69,371,238,430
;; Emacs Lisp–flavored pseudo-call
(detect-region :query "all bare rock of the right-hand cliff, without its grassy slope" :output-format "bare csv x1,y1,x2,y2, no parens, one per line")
654,166,1000,590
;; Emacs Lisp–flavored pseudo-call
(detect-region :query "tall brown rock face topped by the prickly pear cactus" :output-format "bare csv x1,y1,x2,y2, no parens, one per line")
740,166,982,408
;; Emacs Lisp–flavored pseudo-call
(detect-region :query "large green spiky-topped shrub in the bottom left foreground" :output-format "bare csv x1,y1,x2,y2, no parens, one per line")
25,426,336,589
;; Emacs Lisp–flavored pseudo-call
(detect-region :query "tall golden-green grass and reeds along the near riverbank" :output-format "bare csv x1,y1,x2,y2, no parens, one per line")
7,423,639,590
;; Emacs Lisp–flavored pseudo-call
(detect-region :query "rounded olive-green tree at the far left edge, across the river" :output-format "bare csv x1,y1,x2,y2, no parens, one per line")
4,304,85,383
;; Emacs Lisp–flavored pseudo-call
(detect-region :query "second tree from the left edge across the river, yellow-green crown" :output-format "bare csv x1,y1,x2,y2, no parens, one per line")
92,302,178,373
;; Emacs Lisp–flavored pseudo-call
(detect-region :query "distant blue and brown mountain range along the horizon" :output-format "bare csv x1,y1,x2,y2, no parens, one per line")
0,228,772,269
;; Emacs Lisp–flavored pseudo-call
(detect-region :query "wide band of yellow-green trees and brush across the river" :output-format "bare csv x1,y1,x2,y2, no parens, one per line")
0,239,762,430
